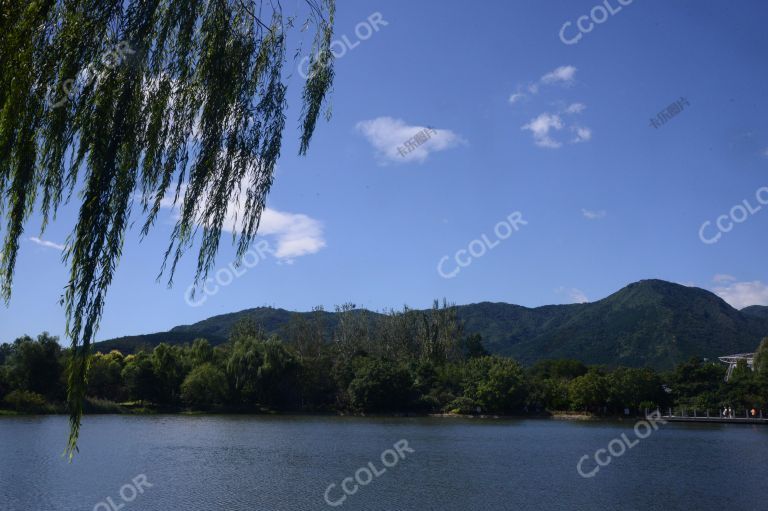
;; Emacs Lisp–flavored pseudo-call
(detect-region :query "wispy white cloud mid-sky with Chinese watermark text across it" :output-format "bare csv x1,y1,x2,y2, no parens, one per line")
357,117,464,163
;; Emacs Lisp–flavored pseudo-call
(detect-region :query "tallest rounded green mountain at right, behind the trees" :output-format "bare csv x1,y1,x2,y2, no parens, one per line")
480,280,768,369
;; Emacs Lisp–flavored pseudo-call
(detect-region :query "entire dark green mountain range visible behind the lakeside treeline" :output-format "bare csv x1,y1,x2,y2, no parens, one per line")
96,280,768,369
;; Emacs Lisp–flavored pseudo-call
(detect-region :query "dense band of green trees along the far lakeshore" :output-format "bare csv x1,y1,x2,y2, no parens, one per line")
0,302,768,415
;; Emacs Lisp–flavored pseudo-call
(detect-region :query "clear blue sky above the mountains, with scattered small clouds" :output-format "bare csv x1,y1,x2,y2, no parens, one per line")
0,0,768,341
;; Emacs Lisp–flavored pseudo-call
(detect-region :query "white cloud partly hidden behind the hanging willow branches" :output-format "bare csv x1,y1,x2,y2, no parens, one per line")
161,182,326,264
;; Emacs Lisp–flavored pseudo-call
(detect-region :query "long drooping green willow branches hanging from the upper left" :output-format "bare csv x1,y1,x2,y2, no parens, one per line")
0,0,335,457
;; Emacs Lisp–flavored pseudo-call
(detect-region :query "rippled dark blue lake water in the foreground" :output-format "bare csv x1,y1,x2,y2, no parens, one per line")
0,416,768,511
